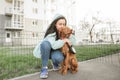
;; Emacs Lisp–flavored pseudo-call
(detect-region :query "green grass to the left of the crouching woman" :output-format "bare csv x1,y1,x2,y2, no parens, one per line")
0,48,40,80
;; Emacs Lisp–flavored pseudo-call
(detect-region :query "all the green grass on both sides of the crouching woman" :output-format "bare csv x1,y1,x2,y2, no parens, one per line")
0,45,120,80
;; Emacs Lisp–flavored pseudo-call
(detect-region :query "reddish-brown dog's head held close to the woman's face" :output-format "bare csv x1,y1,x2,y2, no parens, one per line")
60,26,73,39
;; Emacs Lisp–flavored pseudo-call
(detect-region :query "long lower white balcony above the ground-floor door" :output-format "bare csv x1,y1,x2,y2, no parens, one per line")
4,20,24,30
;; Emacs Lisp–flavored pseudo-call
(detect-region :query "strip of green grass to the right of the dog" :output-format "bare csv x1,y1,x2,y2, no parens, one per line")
75,44,120,61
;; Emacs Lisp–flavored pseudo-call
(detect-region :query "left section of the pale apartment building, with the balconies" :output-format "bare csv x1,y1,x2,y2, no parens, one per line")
0,0,24,45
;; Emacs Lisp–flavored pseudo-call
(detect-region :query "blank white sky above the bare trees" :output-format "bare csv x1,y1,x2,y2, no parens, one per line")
75,0,120,21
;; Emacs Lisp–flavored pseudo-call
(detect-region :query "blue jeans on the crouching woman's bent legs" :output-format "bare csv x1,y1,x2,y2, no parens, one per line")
40,41,64,67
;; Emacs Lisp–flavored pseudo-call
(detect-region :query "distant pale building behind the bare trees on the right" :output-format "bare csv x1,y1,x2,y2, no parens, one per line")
89,22,120,43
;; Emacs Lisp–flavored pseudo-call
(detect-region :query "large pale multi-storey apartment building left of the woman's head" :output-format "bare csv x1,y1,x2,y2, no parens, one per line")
0,0,54,45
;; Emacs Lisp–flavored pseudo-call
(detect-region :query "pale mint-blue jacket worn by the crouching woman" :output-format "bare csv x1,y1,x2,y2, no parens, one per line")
33,33,76,58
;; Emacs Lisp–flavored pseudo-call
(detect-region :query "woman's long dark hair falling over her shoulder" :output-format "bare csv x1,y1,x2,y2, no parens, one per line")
44,16,67,40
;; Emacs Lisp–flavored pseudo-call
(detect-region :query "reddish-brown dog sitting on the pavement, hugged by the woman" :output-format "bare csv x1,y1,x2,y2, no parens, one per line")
59,26,78,75
